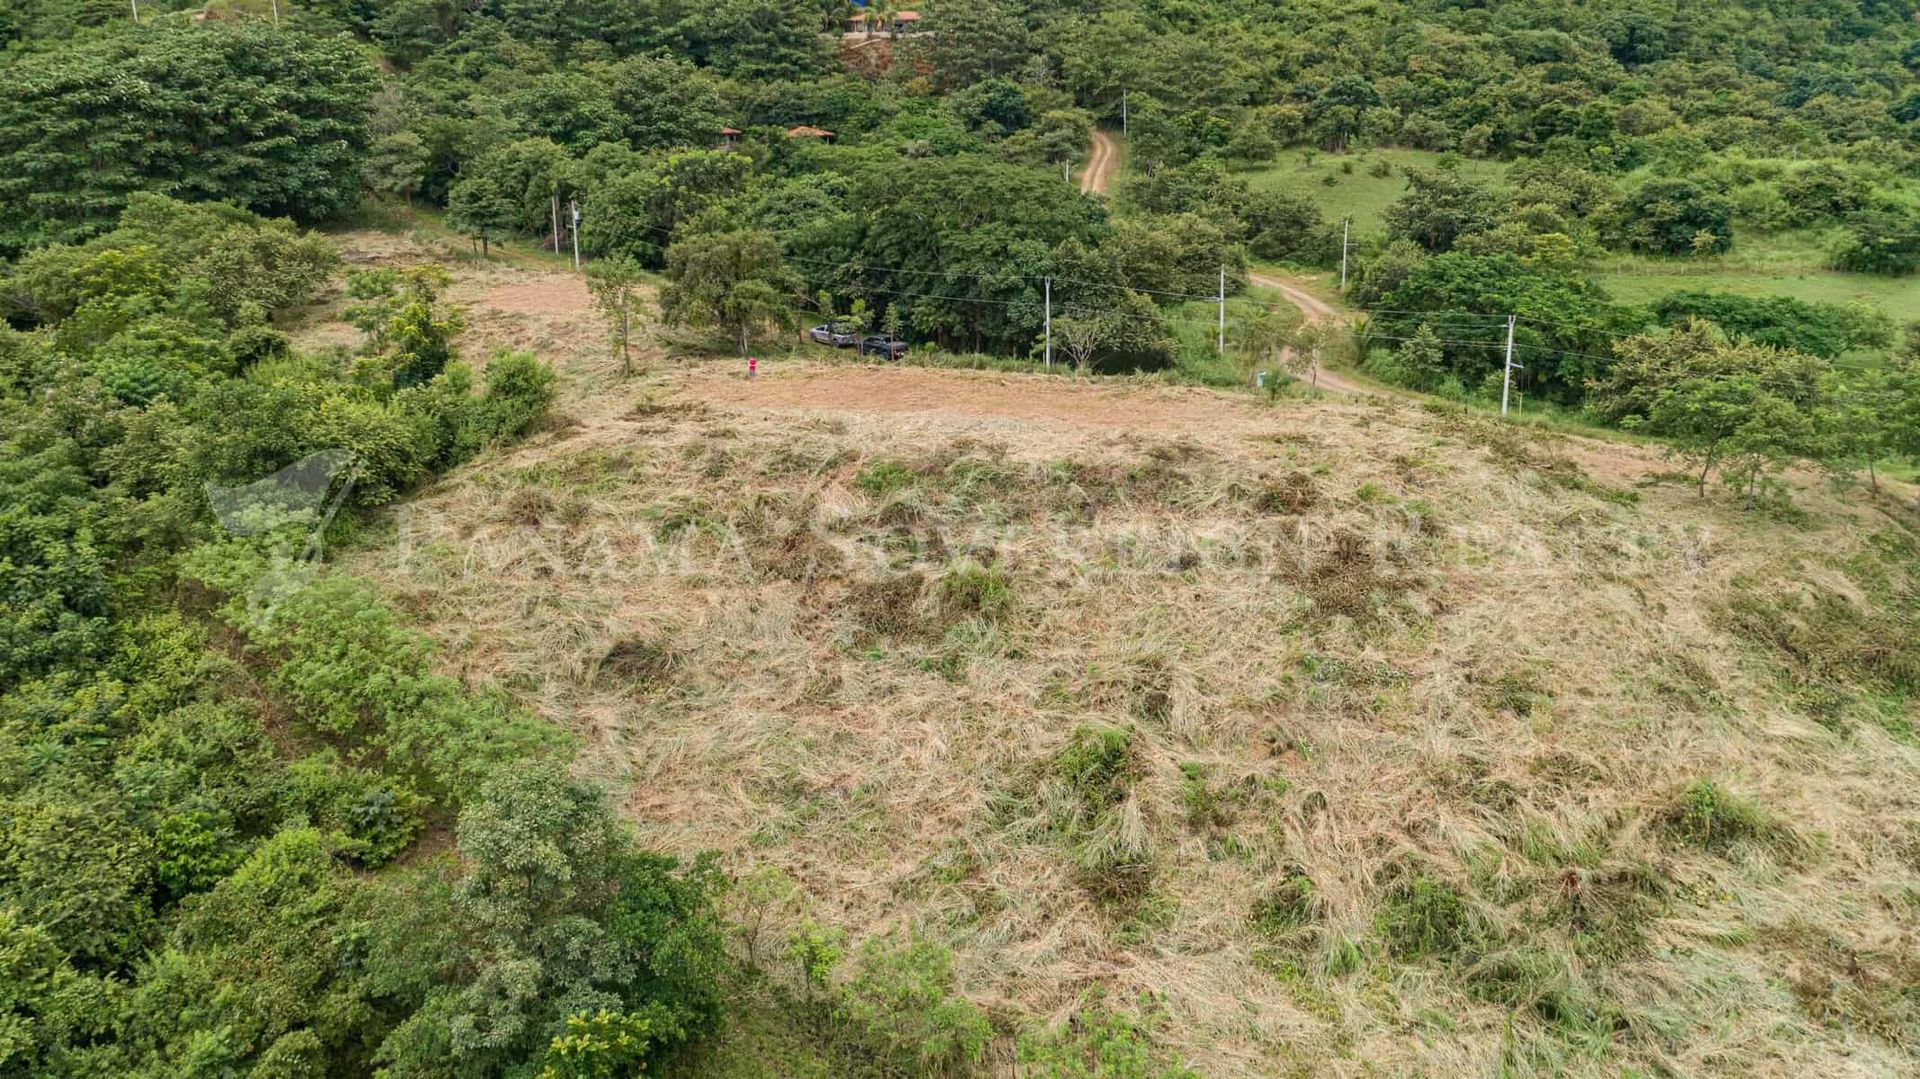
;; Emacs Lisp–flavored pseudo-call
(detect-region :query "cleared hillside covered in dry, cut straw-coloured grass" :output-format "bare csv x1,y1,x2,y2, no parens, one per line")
305,235,1920,1075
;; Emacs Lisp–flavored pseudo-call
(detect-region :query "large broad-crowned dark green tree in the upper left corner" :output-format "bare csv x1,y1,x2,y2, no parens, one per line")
0,19,374,253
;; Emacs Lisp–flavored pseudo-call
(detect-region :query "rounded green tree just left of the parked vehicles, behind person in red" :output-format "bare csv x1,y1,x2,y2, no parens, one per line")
660,232,803,355
